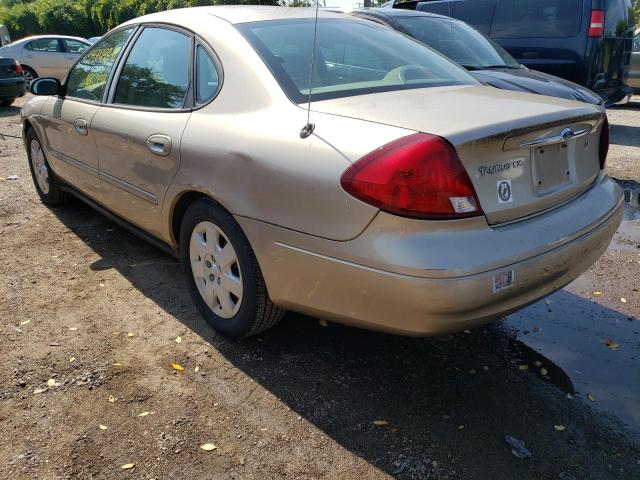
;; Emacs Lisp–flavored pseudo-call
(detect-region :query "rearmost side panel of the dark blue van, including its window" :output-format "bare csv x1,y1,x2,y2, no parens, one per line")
490,0,590,85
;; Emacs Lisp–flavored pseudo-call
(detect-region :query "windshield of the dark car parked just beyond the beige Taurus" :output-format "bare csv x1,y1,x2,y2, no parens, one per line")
396,16,521,70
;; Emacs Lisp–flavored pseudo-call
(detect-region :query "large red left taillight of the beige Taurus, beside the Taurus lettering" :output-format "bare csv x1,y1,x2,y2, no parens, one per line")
340,133,482,219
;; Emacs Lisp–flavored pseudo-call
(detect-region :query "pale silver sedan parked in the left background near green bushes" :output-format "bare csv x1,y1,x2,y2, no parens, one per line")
0,35,91,87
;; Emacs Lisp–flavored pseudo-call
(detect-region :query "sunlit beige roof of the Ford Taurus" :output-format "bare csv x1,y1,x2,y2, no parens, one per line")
126,5,344,25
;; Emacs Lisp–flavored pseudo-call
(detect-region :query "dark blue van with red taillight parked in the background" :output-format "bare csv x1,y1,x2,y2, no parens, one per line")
386,0,635,105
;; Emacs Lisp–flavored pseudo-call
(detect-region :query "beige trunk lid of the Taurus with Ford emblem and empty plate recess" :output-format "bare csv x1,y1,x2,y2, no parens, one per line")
313,86,604,224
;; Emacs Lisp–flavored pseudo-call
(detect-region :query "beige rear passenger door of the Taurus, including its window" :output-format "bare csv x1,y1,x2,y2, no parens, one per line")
91,26,194,235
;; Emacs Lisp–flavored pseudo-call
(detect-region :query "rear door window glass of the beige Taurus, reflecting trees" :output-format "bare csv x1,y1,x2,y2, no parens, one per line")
113,28,191,108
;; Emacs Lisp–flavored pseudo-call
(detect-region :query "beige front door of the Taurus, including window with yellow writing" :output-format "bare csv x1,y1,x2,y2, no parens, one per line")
41,28,133,199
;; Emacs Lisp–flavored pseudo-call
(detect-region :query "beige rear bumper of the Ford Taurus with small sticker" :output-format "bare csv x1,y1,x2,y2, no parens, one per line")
238,177,623,335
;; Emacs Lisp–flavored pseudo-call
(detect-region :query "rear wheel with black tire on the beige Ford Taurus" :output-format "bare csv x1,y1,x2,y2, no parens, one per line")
180,199,284,338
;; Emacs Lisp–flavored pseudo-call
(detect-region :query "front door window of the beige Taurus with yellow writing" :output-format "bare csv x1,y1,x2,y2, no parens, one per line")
67,28,133,102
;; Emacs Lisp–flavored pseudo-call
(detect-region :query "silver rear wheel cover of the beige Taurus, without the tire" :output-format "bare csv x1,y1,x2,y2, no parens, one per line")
189,221,244,318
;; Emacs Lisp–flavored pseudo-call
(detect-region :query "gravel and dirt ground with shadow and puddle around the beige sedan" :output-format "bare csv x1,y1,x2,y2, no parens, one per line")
0,97,640,480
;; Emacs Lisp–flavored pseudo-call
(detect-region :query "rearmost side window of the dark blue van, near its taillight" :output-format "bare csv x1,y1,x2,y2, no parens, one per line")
490,0,583,38
